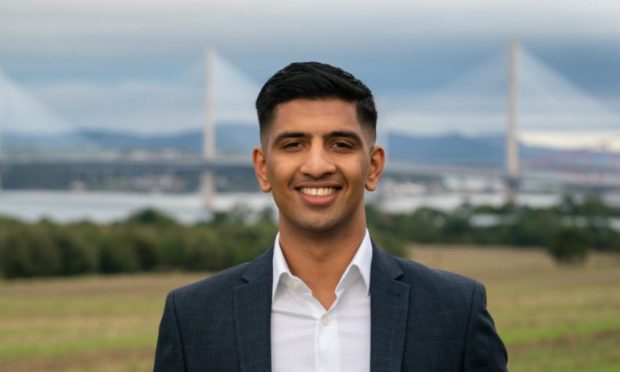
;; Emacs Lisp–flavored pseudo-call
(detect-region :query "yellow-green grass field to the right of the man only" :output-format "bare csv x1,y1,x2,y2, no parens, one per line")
412,246,620,372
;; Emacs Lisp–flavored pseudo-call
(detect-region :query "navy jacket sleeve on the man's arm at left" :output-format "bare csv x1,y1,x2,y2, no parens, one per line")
153,292,186,372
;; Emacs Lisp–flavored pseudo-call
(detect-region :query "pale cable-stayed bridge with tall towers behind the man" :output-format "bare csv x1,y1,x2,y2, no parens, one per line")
0,43,620,207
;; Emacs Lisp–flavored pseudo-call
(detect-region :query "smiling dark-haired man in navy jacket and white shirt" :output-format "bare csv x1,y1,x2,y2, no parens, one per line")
155,62,507,372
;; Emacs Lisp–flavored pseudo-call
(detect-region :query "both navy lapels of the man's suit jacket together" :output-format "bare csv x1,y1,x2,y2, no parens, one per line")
234,243,409,372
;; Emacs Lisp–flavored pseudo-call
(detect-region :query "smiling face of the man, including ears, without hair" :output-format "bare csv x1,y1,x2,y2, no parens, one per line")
253,99,385,233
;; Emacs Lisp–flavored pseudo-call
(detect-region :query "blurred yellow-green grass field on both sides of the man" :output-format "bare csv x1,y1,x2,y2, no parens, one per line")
0,246,620,371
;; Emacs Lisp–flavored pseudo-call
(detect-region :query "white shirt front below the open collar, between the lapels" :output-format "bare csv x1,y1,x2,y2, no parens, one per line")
271,280,371,372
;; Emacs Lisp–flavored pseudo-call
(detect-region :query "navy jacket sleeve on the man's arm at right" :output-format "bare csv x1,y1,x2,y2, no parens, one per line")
463,283,508,372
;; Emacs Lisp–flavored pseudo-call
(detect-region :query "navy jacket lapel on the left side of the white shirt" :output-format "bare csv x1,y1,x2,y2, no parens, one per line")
234,250,273,372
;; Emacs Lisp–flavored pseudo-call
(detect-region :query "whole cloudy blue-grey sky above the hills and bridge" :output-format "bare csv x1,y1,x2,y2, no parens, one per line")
0,0,620,147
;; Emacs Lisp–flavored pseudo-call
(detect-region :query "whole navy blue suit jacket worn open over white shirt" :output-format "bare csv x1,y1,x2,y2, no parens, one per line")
155,247,507,372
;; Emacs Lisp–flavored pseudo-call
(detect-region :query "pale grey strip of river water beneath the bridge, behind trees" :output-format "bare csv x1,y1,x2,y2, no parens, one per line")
0,191,572,223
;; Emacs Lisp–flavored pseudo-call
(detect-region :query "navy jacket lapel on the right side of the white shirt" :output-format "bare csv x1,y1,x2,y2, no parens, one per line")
370,244,409,372
